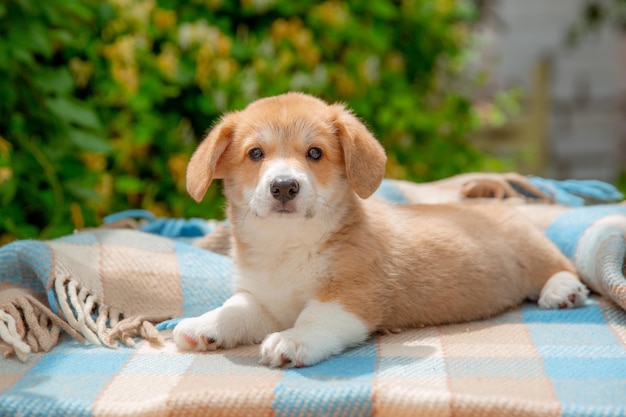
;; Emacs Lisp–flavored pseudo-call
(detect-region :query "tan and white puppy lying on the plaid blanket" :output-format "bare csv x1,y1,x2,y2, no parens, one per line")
173,93,587,367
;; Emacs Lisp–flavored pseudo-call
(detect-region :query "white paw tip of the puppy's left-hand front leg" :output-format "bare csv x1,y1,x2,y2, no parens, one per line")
172,312,225,351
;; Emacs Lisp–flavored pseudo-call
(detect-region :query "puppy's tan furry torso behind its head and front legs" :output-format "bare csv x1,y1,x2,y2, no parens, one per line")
318,201,574,330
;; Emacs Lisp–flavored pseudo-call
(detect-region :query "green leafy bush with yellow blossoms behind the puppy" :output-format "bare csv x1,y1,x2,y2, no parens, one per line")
0,0,498,241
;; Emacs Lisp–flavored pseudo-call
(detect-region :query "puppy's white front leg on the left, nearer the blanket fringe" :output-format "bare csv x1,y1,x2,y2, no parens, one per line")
173,293,280,351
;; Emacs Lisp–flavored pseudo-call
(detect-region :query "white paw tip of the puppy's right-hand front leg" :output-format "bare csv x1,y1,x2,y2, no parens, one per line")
261,329,330,368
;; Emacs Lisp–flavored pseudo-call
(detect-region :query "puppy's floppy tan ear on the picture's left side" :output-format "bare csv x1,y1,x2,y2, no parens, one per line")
187,112,237,202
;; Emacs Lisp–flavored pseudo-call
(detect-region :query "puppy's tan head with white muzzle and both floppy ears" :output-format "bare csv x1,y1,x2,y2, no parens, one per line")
187,93,386,218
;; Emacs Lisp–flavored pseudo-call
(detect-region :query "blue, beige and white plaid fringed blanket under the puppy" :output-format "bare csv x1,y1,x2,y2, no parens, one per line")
0,174,626,416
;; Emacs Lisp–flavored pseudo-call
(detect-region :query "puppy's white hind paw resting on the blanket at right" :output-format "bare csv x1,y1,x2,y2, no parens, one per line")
538,271,589,309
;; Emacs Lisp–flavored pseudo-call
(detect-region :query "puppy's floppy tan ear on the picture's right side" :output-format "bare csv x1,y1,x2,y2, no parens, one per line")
331,104,387,198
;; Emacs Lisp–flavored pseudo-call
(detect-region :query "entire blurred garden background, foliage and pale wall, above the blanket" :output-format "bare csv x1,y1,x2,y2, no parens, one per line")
0,0,626,244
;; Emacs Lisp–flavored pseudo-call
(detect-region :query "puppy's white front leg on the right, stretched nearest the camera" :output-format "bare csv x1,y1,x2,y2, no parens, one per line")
261,300,370,367
